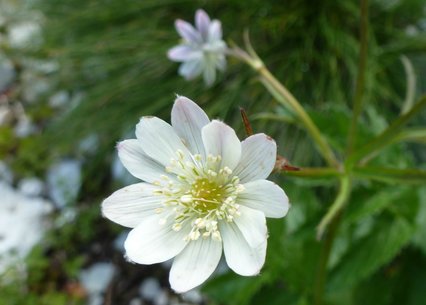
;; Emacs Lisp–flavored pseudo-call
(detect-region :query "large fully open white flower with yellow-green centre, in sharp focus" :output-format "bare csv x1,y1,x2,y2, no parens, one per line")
102,97,289,292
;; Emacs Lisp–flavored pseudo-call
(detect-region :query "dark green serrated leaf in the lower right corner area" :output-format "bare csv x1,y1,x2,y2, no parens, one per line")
329,218,414,289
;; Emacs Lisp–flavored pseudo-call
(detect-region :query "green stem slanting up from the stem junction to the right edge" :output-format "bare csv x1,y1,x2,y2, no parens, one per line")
346,95,426,167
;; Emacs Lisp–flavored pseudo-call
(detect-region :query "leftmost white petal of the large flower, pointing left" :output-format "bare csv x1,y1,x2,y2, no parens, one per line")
102,183,161,228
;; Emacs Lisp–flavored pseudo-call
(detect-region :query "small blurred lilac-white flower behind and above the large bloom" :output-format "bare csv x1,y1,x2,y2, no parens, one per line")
168,9,226,86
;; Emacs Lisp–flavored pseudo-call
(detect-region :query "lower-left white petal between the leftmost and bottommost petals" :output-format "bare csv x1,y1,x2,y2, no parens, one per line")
124,213,191,265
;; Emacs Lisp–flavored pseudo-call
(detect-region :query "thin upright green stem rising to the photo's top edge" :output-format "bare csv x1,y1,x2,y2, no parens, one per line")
347,0,368,154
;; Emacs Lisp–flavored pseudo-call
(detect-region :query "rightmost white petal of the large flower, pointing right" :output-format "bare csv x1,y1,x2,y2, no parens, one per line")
237,180,290,218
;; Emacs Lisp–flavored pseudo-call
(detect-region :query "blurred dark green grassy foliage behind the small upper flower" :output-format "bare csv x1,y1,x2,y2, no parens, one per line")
33,0,426,164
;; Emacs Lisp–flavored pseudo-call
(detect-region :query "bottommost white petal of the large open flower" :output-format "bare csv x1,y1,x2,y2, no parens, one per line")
169,238,222,293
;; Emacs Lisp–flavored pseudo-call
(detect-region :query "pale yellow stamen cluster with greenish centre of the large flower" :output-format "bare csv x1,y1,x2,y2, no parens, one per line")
154,150,244,241
